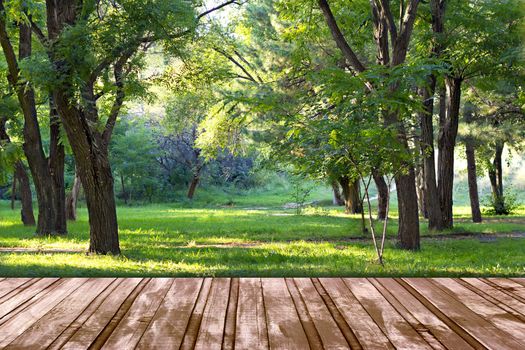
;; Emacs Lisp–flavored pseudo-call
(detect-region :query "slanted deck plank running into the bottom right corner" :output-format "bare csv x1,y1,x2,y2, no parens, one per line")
403,278,521,349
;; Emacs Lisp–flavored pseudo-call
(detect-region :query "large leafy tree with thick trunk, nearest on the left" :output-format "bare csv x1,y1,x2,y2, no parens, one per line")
41,0,196,254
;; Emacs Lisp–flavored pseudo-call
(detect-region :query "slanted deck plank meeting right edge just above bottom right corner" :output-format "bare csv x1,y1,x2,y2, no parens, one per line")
432,278,525,348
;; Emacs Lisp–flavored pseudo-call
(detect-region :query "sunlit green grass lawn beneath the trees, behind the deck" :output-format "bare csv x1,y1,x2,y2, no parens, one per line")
0,196,525,276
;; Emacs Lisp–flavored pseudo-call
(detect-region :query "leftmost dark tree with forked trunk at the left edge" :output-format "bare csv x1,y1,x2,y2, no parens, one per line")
0,1,67,235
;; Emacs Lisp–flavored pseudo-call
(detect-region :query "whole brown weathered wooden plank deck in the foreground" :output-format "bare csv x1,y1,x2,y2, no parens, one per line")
0,278,525,350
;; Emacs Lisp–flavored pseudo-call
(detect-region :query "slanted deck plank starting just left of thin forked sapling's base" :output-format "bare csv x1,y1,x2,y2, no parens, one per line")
343,278,431,349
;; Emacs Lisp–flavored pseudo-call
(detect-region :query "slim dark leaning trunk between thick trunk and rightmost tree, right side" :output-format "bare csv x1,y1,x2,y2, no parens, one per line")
464,106,482,222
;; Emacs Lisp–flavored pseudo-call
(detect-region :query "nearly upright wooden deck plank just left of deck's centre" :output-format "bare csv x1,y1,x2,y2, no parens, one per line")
235,278,268,349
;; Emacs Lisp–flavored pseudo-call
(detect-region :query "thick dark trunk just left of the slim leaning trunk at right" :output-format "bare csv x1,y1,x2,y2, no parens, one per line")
438,77,462,228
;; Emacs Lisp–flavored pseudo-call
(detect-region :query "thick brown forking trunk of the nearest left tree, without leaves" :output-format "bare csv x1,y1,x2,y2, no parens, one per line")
46,0,118,254
